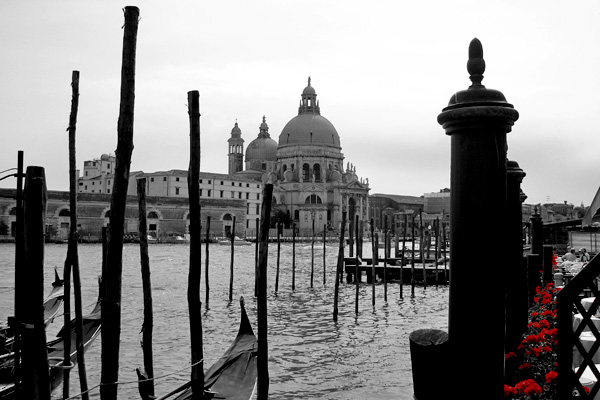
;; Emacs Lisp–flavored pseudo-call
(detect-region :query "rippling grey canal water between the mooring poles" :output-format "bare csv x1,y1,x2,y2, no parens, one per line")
0,243,448,400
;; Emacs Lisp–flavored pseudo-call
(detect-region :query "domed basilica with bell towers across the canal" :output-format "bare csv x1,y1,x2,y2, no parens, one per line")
228,78,369,230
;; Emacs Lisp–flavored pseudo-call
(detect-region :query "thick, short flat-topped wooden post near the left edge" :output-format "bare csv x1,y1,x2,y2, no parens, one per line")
21,167,50,400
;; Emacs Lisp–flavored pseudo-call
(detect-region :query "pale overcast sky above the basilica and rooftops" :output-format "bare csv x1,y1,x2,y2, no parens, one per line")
0,0,600,205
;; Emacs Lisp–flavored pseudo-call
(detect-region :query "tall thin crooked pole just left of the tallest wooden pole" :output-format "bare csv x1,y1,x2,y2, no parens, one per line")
63,71,89,400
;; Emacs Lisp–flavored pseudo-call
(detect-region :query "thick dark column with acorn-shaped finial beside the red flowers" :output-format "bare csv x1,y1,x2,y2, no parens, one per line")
438,39,519,400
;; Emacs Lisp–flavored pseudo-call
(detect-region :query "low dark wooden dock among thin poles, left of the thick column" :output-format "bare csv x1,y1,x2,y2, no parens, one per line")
344,258,450,285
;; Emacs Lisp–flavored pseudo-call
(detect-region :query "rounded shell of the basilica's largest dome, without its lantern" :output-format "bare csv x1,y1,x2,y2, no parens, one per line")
279,114,340,148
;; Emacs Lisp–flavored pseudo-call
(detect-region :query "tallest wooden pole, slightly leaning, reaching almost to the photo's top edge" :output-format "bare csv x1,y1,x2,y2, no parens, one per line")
100,6,140,400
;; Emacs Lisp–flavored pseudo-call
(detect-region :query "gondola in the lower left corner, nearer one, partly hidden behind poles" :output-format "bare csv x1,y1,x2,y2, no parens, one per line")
0,300,101,400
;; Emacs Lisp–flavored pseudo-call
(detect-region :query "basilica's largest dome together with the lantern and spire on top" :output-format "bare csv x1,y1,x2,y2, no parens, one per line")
279,77,341,149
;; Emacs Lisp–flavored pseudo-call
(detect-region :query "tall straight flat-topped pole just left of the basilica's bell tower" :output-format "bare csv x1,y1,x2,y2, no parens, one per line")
187,90,204,399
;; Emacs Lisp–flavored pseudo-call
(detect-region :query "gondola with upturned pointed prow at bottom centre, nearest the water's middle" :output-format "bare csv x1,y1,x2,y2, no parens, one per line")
136,298,258,400
